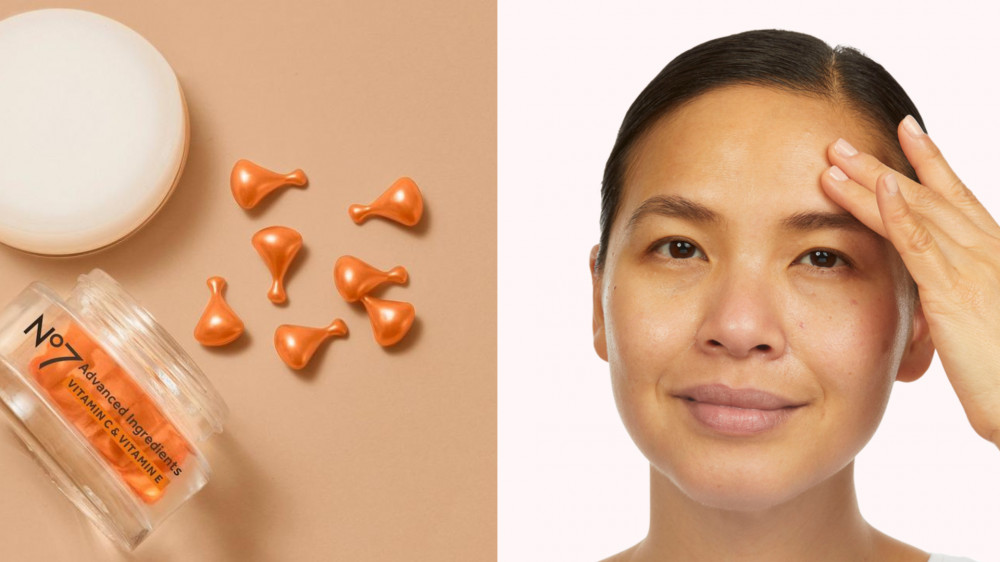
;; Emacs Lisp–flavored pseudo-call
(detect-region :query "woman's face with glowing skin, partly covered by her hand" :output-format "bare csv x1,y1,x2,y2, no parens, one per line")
591,86,933,510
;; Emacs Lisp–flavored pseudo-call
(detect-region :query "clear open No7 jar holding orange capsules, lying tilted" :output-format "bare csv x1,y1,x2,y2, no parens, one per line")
0,269,229,550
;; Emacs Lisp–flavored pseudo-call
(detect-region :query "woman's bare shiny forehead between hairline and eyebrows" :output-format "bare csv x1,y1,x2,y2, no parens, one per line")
618,85,874,230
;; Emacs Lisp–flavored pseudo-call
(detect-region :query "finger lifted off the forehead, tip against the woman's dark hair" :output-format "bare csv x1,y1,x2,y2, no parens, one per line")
896,115,1000,237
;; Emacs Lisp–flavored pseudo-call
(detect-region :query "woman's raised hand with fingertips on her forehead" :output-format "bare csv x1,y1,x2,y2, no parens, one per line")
821,115,1000,447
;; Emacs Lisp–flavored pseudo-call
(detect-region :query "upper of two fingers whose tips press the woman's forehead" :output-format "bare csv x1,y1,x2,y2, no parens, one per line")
827,139,983,247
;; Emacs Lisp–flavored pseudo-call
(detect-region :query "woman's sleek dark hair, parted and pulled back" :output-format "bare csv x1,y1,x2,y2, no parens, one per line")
594,29,927,296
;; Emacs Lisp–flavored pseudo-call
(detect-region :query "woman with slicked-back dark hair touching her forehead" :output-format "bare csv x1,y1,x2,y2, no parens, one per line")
590,30,1000,562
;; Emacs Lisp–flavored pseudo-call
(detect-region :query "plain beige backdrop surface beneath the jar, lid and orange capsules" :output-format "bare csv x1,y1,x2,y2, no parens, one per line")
0,0,497,562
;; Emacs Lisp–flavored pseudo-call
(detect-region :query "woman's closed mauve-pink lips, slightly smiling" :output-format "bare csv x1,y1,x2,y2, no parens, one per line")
674,384,805,435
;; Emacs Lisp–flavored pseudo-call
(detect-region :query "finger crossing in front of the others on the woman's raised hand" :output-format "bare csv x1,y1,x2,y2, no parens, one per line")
875,172,959,295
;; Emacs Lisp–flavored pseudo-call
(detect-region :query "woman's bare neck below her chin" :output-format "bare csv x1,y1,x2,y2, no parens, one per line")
633,460,878,562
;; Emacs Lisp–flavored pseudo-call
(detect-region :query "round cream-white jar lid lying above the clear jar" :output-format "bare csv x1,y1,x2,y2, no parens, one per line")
0,9,188,255
